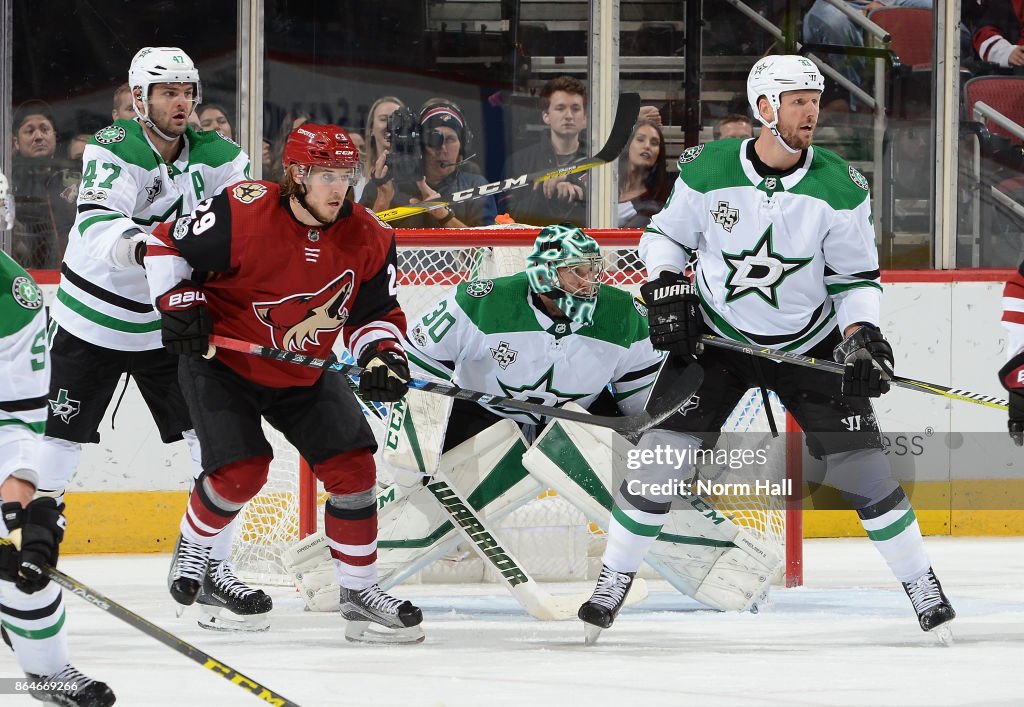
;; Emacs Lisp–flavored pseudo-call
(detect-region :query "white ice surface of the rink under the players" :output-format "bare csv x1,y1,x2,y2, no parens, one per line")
0,538,1024,707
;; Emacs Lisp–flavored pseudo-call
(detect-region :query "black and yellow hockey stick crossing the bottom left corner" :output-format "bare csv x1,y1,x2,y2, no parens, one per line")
0,549,298,707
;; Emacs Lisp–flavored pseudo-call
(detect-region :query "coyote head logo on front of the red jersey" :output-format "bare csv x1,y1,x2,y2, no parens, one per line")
253,271,355,351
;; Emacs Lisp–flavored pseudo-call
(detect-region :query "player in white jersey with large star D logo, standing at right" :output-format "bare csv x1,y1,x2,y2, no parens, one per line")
580,55,955,640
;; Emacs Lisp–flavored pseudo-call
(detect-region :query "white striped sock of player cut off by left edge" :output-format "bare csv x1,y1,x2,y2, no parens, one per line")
0,582,71,675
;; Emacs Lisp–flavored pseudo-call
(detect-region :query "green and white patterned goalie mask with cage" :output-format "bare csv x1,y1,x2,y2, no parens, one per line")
526,225,604,326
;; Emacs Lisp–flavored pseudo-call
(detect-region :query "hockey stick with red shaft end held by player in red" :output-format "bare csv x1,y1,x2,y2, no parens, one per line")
206,335,703,436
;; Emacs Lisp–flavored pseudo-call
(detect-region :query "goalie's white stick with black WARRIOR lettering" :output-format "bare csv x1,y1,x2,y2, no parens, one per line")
417,474,647,621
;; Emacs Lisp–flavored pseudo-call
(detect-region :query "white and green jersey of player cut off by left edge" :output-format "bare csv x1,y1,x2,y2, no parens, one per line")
0,250,50,484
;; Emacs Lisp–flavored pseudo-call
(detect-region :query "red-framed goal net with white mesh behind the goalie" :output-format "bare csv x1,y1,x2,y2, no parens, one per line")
232,226,802,586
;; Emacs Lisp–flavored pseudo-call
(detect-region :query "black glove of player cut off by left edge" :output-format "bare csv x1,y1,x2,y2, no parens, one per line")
0,497,68,594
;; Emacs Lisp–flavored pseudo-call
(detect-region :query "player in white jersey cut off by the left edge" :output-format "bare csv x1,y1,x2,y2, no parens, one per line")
0,174,115,707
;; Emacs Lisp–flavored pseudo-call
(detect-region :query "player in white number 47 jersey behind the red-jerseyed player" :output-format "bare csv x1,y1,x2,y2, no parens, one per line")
40,47,272,628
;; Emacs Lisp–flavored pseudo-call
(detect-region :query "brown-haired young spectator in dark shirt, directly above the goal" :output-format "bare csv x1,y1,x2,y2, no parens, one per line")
502,76,587,226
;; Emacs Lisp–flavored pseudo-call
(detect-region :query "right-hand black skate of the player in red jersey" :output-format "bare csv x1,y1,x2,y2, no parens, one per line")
341,584,424,643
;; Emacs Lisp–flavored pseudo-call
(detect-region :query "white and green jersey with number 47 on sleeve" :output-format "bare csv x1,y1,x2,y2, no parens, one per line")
51,120,249,351
